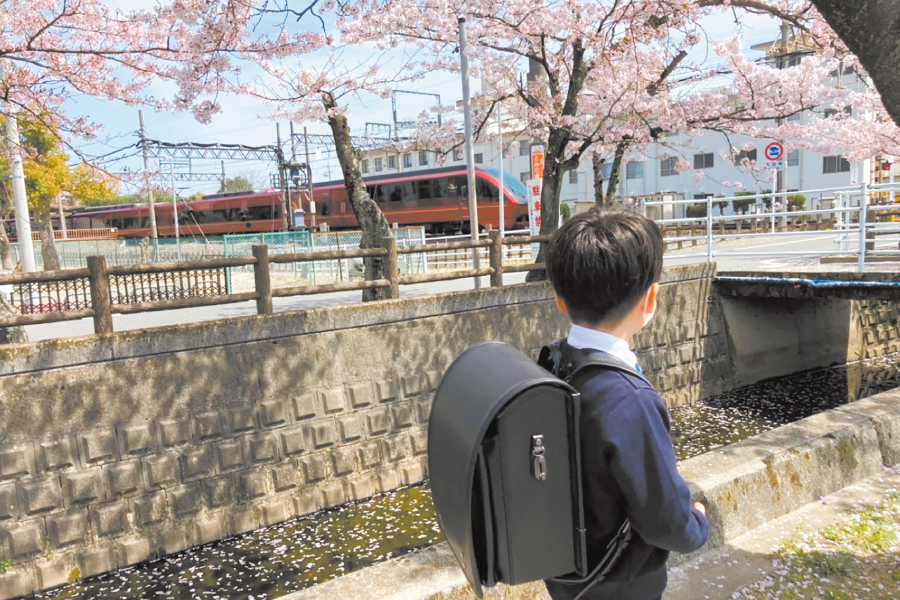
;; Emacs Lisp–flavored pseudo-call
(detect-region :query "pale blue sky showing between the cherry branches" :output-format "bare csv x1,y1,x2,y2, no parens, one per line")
67,5,779,195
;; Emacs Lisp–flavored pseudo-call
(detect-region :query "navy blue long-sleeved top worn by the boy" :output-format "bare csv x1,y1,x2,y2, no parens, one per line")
548,358,709,600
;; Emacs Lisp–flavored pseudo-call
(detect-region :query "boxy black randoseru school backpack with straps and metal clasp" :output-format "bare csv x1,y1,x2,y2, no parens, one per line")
428,340,634,598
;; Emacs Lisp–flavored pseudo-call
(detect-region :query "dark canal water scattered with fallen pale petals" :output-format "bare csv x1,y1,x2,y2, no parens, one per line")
35,354,900,600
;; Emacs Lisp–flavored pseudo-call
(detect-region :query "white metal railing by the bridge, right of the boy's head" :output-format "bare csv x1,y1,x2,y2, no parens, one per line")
640,183,900,273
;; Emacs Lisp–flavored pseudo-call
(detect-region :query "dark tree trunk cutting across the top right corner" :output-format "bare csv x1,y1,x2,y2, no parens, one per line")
812,0,900,123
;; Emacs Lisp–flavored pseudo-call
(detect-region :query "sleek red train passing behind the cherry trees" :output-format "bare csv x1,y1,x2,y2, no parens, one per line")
14,167,528,238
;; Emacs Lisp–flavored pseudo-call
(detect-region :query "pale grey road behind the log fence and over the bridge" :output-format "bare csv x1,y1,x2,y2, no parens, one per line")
25,232,900,341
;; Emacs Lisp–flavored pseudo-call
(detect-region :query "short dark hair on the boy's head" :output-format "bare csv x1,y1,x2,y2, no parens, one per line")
546,207,664,325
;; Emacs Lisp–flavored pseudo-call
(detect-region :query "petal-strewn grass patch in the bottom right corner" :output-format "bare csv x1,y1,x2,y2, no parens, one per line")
734,493,900,600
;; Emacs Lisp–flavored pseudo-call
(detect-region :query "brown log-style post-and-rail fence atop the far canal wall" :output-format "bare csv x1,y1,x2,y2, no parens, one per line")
0,231,550,333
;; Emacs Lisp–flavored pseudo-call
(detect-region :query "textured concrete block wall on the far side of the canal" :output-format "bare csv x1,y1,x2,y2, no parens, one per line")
0,265,897,599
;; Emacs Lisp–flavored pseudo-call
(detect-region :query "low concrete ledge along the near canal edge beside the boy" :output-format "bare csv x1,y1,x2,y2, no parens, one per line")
285,391,900,600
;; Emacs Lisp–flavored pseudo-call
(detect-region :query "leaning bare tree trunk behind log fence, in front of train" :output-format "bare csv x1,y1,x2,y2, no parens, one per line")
322,93,392,302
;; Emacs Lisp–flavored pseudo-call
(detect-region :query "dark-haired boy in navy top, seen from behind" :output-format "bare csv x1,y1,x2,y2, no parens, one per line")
546,208,709,600
